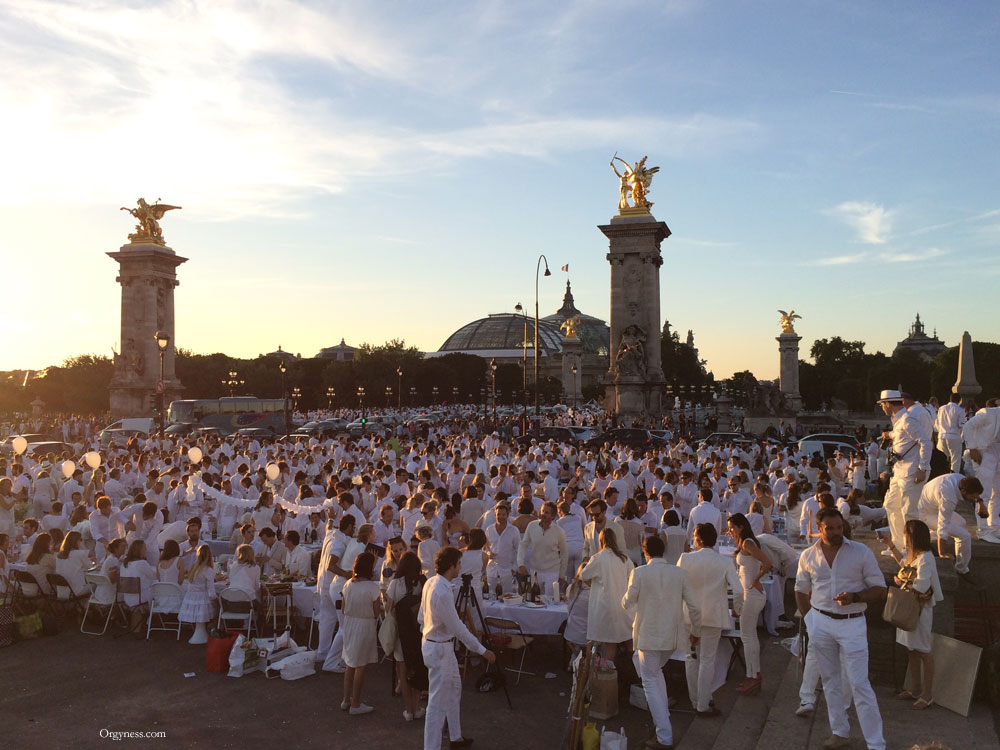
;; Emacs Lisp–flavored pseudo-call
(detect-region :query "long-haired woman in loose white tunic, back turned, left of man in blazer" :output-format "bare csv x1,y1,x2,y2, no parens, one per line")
580,527,635,659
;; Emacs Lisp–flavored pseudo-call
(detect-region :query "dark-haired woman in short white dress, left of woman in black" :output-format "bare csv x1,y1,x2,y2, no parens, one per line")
340,552,382,716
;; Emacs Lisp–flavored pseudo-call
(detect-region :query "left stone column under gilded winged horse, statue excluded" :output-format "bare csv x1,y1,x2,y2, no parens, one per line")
108,242,187,418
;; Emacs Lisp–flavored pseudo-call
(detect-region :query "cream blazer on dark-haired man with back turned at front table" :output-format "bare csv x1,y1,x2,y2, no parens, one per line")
622,557,701,651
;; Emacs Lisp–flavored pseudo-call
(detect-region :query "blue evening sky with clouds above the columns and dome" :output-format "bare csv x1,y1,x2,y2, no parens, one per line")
0,0,1000,378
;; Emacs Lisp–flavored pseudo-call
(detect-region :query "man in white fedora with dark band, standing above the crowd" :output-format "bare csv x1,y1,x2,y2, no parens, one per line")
878,390,932,549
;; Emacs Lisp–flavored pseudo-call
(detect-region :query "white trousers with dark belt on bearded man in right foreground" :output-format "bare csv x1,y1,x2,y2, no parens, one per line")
806,609,885,750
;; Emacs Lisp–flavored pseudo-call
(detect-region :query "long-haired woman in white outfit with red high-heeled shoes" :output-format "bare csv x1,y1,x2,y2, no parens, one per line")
729,513,772,695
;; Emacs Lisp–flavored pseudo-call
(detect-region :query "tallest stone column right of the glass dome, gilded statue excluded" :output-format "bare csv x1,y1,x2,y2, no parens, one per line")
599,211,670,419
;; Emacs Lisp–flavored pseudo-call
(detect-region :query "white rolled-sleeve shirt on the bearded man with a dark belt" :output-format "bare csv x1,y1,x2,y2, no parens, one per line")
795,539,885,614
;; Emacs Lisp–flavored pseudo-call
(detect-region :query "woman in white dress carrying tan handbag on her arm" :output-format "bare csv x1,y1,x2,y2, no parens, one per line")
879,520,944,710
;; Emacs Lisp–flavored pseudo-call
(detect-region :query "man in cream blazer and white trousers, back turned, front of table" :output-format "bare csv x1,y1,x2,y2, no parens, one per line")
622,536,701,750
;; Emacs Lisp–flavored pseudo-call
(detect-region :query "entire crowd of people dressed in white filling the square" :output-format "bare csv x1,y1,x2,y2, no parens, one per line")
0,391,1000,750
